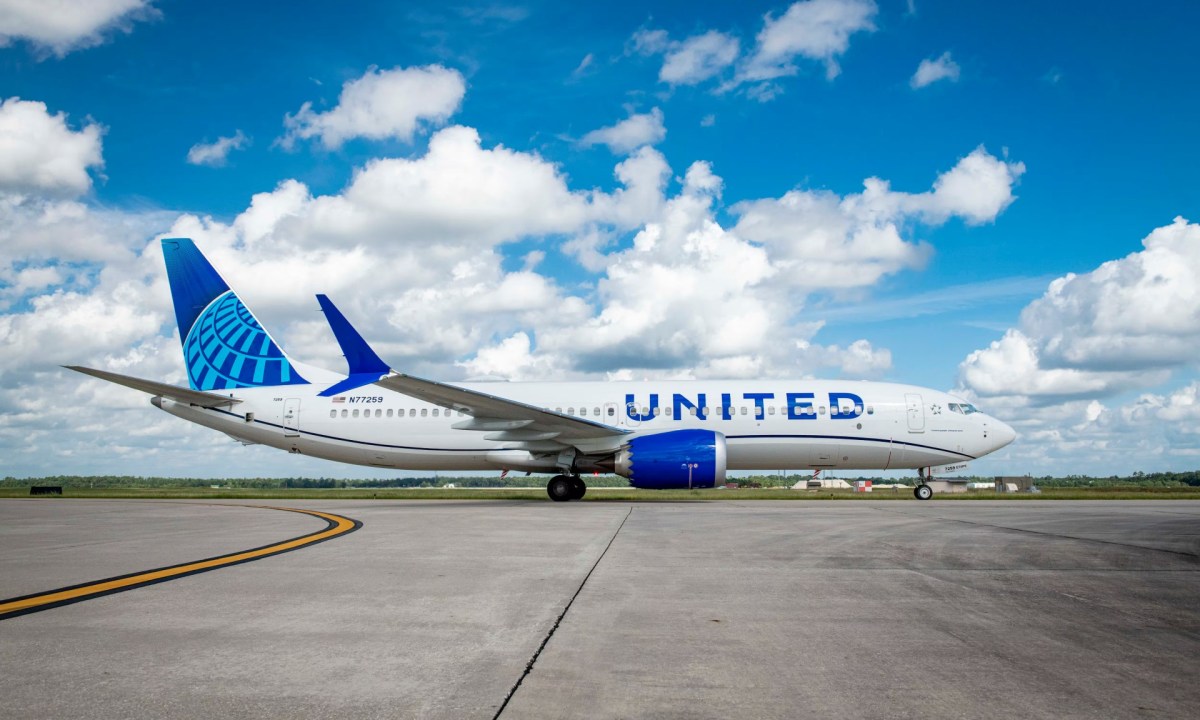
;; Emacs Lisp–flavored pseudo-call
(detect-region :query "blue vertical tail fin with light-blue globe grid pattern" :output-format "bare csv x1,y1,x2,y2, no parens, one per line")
162,238,307,390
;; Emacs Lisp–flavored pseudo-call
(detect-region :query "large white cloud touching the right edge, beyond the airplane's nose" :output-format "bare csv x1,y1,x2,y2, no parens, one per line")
959,217,1200,406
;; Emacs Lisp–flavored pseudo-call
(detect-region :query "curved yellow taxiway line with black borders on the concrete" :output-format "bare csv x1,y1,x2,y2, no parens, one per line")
0,505,362,620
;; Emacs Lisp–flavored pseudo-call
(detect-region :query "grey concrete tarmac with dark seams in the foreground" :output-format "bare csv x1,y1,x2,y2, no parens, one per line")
0,499,1200,719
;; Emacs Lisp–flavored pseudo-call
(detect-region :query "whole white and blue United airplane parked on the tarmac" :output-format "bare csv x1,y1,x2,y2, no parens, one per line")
66,238,1016,502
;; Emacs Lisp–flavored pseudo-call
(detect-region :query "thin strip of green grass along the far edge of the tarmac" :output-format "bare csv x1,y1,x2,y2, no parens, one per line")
0,487,1200,503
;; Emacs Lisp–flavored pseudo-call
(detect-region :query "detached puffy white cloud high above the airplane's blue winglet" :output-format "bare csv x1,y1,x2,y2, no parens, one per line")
281,65,467,149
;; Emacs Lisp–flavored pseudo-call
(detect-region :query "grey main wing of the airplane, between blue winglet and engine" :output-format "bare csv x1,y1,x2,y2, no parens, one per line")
374,373,630,445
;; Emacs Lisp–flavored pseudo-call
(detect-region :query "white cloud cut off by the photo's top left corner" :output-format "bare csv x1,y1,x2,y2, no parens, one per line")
0,0,157,58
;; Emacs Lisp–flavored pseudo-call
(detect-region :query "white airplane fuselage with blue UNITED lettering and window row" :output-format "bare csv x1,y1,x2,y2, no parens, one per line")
155,380,1014,472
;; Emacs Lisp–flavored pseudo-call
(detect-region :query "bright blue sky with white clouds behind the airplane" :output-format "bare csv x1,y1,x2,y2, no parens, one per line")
0,0,1200,476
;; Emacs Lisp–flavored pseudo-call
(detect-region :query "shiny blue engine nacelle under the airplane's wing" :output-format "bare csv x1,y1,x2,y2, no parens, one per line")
613,430,726,490
